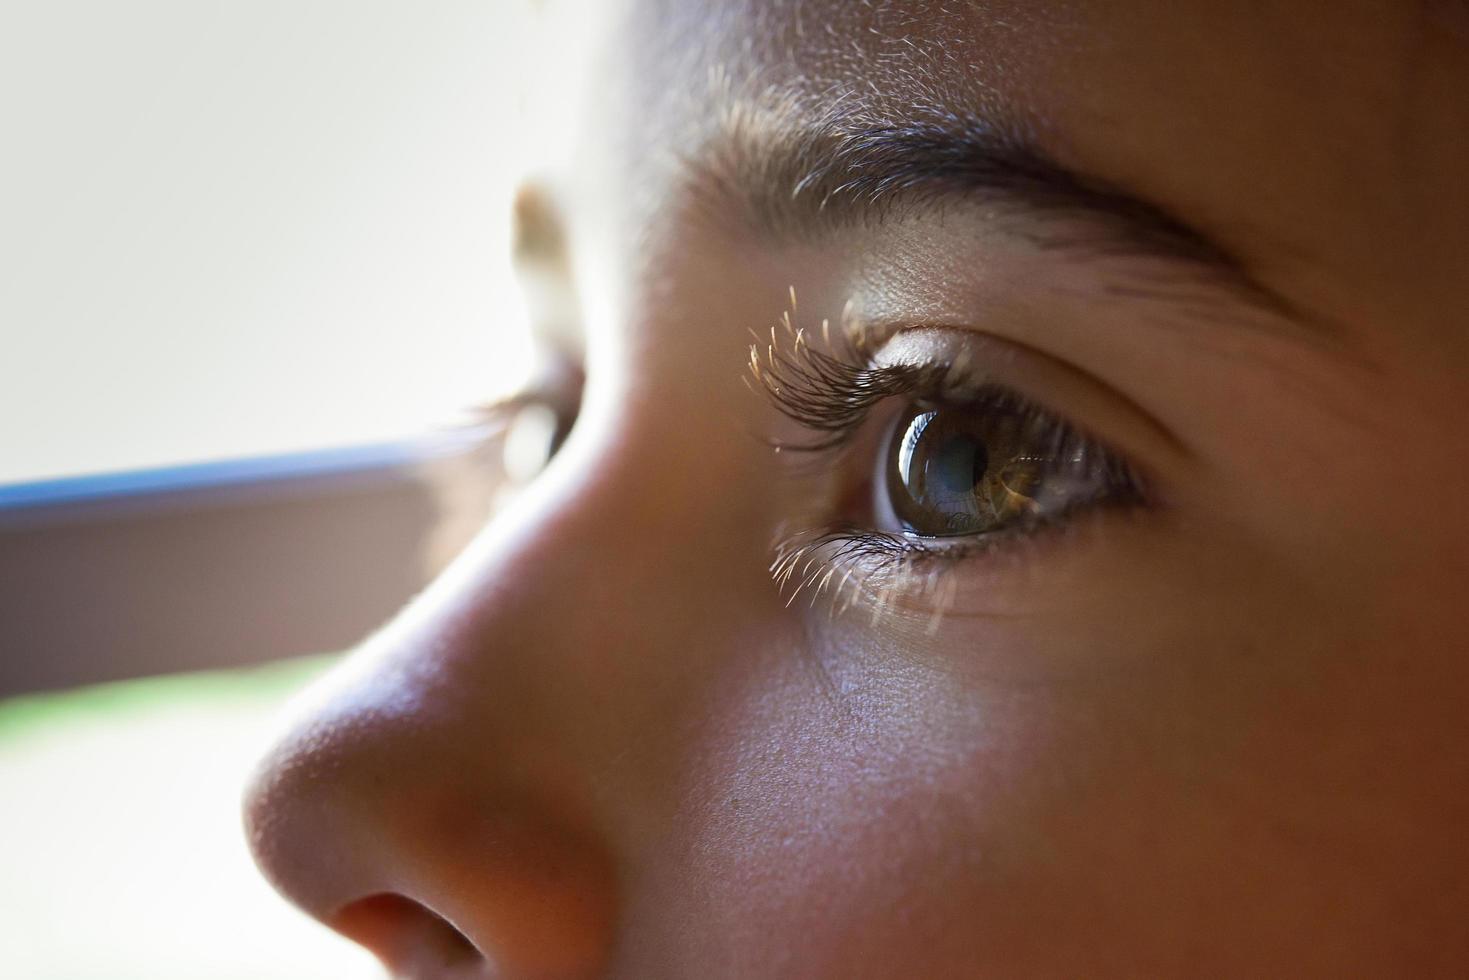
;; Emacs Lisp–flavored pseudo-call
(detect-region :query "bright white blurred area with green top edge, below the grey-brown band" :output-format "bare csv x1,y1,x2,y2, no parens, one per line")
0,657,382,980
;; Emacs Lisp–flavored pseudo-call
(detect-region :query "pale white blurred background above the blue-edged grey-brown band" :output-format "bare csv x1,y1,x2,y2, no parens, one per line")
0,0,546,483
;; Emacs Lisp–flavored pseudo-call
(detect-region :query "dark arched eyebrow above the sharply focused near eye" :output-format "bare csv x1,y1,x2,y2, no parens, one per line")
685,104,1290,313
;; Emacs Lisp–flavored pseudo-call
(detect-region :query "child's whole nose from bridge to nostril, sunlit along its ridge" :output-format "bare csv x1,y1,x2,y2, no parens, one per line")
245,417,764,979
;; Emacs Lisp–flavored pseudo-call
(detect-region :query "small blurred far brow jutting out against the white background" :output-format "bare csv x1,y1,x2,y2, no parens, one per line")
511,184,586,364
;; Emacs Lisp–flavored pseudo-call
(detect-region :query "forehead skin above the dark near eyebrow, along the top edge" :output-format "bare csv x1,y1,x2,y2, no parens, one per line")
599,0,1469,343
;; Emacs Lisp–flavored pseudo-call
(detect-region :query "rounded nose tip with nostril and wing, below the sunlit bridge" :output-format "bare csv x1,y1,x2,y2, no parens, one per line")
245,702,614,980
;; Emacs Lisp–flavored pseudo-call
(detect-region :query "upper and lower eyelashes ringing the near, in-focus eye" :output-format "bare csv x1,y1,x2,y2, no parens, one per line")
748,331,1146,605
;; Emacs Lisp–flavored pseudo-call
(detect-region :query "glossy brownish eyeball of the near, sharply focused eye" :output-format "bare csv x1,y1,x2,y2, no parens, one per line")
881,400,1125,538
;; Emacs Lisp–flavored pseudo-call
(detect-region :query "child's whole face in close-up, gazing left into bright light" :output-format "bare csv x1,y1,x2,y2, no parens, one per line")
248,0,1469,979
